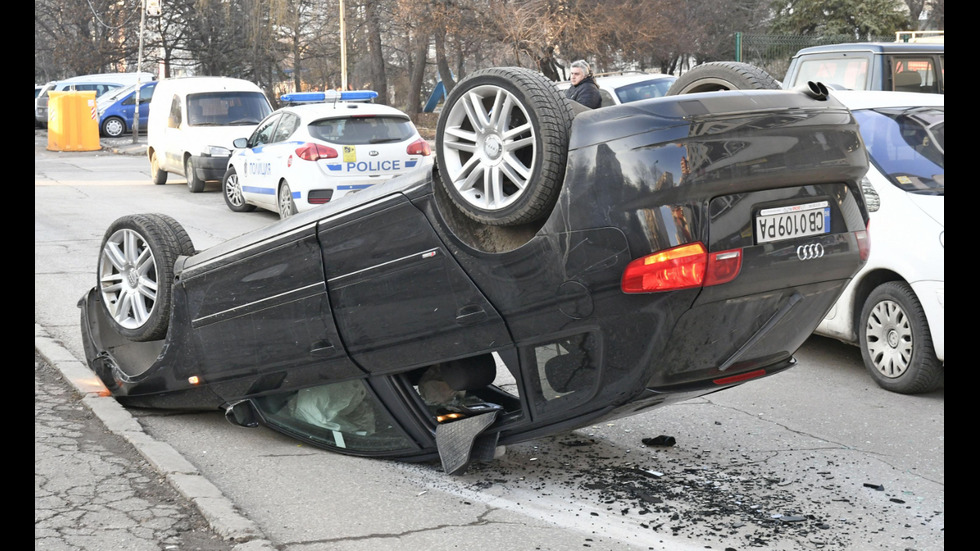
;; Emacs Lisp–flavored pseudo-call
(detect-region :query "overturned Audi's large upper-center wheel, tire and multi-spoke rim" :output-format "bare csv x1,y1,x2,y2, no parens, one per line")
436,67,573,226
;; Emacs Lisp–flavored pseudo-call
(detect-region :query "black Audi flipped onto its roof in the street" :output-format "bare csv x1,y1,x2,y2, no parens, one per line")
80,69,867,472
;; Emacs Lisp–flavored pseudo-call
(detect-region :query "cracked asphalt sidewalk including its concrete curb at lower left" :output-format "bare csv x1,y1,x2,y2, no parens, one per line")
34,325,274,551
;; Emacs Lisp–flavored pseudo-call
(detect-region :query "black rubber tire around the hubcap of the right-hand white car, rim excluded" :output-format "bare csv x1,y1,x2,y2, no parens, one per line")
858,281,945,394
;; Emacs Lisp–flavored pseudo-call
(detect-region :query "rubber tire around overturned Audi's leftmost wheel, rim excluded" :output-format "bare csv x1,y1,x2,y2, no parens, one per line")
95,214,184,342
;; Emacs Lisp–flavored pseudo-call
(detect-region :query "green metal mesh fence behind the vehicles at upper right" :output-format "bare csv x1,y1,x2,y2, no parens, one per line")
735,33,895,80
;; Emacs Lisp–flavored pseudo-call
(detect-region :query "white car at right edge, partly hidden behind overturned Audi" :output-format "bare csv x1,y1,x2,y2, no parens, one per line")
817,91,946,394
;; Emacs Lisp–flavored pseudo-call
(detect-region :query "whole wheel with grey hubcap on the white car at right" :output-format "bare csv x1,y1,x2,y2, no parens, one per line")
858,281,944,394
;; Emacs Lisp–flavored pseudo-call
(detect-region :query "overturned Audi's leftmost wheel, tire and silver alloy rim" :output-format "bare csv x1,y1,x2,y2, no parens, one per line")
96,214,184,341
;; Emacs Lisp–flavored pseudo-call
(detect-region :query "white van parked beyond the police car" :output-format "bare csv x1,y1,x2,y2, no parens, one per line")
146,77,272,193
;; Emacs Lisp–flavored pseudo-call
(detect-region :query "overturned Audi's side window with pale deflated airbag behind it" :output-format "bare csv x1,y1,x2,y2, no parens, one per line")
253,380,414,452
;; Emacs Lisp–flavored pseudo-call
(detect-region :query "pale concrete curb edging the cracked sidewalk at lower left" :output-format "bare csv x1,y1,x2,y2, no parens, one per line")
34,323,275,551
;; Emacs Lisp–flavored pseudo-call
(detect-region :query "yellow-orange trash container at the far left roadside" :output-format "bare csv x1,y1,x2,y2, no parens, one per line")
48,91,102,151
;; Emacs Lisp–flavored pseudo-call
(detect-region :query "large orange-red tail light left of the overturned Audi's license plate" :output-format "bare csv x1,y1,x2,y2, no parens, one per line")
620,242,742,293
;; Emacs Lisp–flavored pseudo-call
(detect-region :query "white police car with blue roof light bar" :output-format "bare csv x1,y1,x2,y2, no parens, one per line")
228,91,432,218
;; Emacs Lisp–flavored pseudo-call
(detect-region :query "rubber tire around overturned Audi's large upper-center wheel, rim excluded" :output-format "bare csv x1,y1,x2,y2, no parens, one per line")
436,67,575,226
